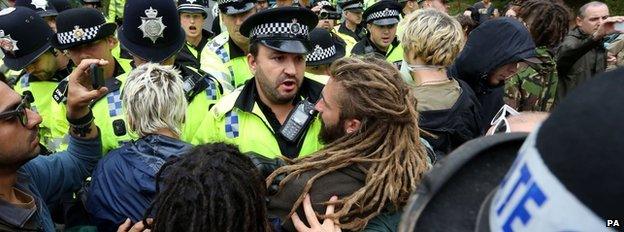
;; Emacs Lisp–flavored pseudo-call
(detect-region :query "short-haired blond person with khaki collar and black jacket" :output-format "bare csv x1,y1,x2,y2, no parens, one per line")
401,9,481,156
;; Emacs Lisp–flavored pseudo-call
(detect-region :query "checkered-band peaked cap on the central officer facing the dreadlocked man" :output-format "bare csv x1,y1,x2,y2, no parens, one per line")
240,6,318,54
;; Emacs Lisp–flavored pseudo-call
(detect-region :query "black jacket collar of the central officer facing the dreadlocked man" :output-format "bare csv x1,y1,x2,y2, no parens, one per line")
234,77,325,113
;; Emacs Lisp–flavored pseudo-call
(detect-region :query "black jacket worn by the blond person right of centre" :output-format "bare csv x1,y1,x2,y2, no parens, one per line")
418,80,483,159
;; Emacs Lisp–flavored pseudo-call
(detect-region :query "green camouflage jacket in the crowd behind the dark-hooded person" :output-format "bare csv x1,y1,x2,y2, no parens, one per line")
505,47,558,112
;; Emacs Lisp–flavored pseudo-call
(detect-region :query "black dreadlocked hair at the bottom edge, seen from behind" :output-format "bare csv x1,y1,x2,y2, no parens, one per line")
143,143,270,232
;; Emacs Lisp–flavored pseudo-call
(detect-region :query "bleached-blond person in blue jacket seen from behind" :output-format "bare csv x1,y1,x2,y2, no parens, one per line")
86,63,192,231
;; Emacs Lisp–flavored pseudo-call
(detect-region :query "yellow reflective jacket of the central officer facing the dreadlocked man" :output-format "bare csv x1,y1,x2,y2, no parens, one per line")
191,78,323,158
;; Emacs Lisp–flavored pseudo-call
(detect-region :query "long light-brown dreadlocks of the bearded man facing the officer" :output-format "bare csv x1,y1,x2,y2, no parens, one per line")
266,57,428,230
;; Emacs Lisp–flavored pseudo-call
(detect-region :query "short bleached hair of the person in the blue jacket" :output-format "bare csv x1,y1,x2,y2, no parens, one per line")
122,63,188,137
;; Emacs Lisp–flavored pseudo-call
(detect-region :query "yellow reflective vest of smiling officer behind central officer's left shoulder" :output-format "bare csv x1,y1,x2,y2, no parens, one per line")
200,31,253,89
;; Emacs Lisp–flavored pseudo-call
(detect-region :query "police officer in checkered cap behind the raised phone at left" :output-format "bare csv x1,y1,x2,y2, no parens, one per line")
50,8,132,151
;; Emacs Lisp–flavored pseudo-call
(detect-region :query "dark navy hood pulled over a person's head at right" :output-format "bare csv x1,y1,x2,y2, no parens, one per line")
448,18,535,94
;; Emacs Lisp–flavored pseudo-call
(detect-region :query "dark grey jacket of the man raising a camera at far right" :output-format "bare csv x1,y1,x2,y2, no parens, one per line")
556,27,607,102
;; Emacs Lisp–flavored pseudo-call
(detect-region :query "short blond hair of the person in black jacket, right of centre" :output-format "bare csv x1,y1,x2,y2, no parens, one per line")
401,9,464,67
